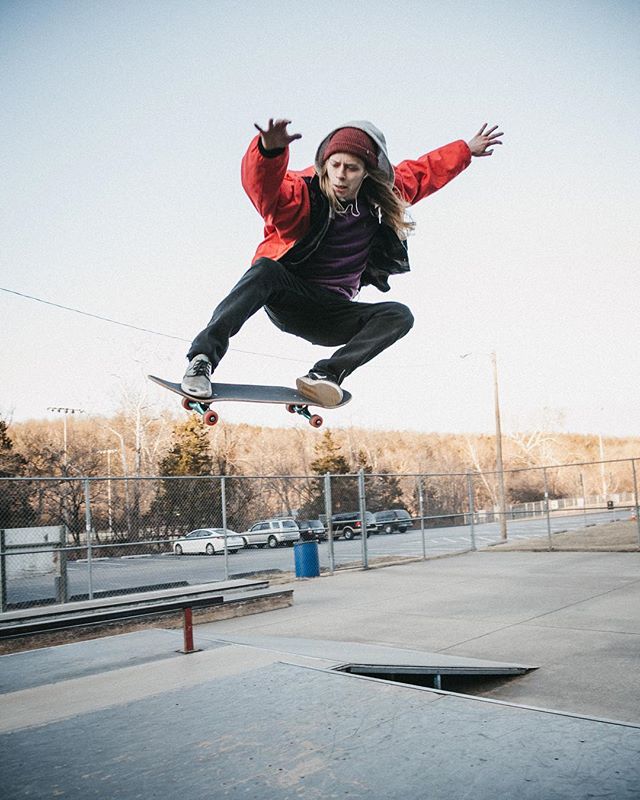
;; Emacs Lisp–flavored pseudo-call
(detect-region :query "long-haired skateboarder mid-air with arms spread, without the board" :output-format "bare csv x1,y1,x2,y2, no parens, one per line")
182,119,503,406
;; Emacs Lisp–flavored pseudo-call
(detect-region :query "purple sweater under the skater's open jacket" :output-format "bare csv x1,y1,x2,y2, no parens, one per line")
300,195,378,300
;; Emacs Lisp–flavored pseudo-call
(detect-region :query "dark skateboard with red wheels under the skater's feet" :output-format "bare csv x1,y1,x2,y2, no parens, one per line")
147,375,351,428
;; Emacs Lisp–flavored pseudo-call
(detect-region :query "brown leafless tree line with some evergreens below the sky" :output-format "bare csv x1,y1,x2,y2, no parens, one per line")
0,406,640,542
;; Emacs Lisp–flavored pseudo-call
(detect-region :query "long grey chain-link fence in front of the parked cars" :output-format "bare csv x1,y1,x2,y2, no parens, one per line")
0,459,640,611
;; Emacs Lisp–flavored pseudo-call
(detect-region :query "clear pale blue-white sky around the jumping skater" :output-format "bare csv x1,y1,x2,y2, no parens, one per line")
0,0,640,436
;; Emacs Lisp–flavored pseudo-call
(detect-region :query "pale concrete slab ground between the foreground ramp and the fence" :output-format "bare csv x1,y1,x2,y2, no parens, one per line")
203,552,640,724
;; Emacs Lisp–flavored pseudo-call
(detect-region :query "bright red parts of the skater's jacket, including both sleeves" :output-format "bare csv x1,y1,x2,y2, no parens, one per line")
242,135,471,262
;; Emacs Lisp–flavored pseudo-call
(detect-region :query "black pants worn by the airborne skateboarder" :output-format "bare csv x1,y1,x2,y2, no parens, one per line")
187,258,413,382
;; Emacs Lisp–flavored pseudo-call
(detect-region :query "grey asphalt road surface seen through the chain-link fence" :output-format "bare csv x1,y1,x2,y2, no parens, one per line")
7,510,631,607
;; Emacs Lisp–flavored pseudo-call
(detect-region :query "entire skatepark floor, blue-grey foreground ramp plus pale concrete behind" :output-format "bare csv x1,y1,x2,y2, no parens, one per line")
0,551,640,800
